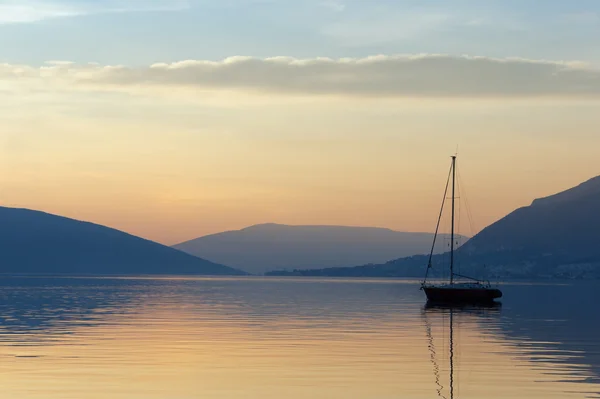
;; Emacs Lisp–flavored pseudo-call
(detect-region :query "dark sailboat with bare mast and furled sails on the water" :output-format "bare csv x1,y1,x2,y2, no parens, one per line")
421,155,502,304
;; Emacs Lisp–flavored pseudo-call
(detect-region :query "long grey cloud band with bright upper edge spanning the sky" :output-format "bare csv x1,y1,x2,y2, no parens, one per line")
0,55,600,98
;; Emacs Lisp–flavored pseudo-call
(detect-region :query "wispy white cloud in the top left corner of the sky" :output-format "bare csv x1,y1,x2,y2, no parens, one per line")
0,0,189,24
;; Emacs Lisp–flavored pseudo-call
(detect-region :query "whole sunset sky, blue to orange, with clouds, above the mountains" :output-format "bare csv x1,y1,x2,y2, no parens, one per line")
0,0,600,244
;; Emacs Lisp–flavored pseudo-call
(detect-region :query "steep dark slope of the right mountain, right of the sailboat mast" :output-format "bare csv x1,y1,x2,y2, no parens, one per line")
458,176,600,277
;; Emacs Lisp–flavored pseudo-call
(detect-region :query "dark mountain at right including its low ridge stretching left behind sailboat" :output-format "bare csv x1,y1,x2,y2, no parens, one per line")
272,176,600,278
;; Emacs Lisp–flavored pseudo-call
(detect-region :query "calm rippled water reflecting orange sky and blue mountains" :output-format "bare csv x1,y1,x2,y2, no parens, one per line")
0,278,600,399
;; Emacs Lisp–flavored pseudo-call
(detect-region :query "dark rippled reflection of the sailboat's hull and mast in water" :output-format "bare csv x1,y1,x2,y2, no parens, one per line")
422,301,502,399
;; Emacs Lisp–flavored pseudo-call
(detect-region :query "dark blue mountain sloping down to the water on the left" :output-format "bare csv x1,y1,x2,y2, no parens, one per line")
0,207,244,275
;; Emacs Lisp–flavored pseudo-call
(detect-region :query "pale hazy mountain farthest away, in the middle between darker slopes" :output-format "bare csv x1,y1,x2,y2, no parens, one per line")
174,223,466,273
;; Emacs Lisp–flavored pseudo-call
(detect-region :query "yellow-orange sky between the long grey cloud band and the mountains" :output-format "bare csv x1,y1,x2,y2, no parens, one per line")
0,94,600,244
